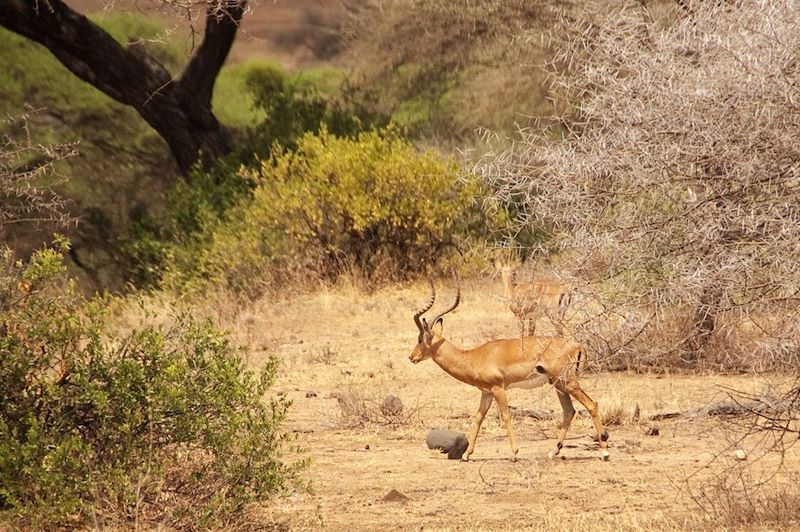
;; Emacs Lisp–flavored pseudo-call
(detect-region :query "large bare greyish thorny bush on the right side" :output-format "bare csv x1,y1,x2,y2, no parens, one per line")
477,0,800,368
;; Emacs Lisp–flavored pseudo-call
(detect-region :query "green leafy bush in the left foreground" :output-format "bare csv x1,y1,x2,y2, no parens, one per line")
0,241,304,528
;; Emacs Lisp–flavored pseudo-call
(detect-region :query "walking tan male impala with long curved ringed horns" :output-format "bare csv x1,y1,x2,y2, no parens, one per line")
409,278,608,460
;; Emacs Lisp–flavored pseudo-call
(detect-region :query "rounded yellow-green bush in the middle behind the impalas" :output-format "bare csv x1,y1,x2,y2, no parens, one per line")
172,130,493,295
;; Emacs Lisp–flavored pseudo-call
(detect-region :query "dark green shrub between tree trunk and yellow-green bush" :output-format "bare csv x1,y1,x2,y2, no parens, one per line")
150,62,388,290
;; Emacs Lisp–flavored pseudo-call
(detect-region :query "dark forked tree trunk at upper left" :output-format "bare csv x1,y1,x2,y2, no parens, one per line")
0,0,246,174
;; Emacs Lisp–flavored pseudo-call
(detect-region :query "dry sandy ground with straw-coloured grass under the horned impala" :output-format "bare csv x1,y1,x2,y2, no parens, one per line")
209,281,798,530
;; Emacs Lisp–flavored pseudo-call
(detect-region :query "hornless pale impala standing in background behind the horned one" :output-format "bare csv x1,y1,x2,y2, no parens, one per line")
495,260,572,336
